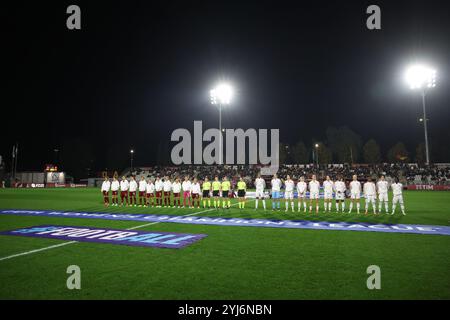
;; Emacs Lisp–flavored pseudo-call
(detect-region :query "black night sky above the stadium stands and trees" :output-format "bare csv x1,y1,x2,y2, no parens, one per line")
0,0,450,175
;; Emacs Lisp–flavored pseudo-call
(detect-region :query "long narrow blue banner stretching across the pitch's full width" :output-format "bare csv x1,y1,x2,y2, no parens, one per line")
0,209,450,236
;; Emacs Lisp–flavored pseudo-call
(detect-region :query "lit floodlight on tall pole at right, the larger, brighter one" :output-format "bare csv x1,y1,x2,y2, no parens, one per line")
405,65,436,165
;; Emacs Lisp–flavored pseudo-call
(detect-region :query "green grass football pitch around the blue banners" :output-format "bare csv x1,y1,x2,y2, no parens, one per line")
0,189,450,299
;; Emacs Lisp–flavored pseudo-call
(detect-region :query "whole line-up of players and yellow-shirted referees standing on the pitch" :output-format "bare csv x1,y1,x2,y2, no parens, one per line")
102,175,405,215
